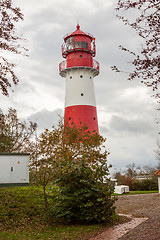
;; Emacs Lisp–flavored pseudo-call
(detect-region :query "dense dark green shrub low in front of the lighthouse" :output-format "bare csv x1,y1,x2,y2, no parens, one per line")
53,160,115,223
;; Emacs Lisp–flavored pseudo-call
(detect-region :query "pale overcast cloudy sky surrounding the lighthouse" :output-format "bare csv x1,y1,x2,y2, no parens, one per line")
0,0,158,174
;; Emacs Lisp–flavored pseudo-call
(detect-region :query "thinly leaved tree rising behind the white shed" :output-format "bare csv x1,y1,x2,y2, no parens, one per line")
0,108,37,153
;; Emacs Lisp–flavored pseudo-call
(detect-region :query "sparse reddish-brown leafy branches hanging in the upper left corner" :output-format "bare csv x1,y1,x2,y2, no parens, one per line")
0,0,27,96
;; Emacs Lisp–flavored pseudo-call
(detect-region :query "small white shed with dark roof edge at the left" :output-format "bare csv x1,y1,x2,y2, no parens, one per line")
0,153,29,185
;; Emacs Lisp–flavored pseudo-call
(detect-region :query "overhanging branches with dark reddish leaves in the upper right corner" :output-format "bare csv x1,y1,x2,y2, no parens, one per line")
112,0,160,99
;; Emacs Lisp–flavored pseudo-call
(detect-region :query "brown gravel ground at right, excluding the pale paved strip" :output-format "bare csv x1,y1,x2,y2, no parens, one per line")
116,193,160,240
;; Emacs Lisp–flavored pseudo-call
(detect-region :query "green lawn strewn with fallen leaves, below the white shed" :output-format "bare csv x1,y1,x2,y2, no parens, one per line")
0,186,114,240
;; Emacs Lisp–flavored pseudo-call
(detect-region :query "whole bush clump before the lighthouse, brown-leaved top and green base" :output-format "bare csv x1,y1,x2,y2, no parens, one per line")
31,121,115,223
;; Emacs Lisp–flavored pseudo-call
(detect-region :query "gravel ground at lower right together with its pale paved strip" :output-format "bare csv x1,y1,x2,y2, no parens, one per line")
90,193,160,240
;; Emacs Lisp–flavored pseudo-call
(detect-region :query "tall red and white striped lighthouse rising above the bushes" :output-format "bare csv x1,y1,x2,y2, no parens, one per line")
59,24,99,133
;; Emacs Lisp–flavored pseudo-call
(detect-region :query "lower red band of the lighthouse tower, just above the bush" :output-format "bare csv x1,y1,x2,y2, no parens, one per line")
64,105,99,133
